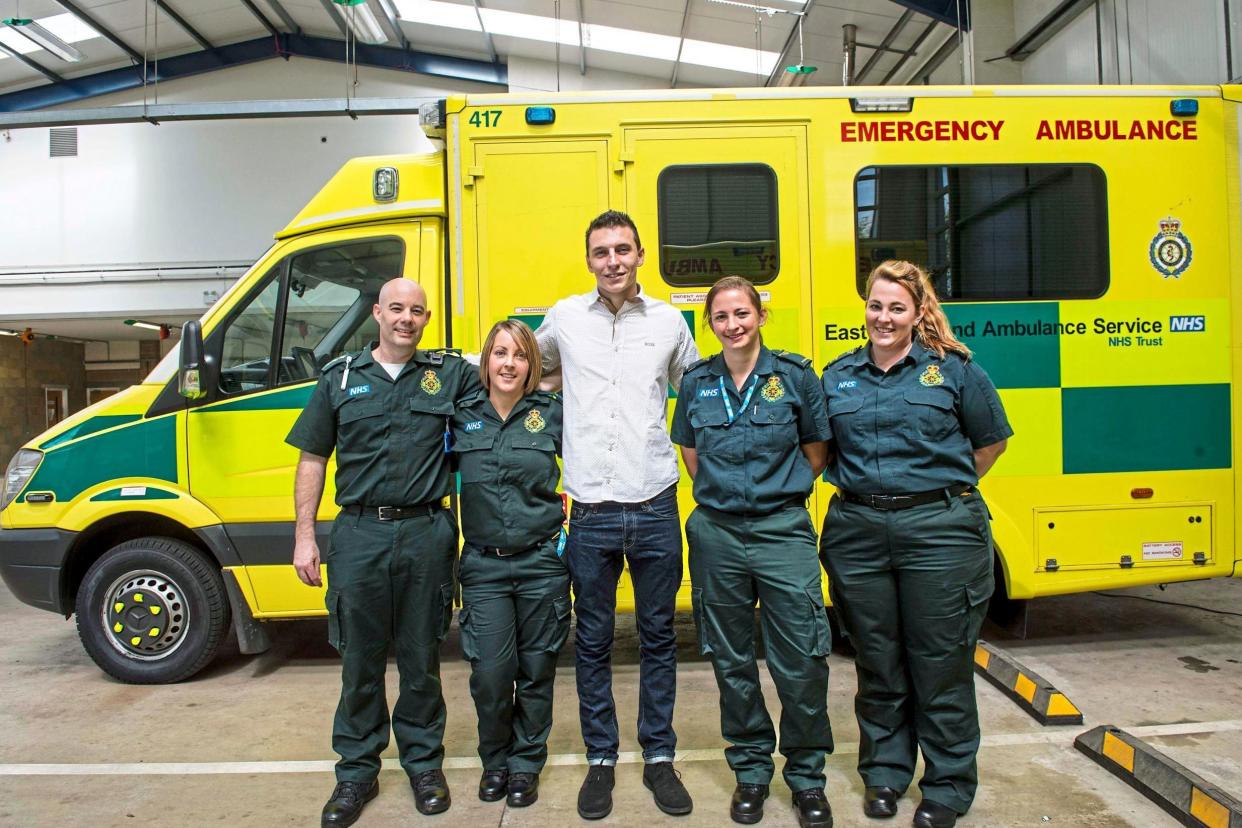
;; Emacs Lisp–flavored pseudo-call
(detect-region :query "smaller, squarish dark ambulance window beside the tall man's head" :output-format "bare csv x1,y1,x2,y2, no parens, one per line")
656,164,780,287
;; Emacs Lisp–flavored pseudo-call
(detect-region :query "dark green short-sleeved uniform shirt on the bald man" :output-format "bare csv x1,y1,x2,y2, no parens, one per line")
284,345,482,506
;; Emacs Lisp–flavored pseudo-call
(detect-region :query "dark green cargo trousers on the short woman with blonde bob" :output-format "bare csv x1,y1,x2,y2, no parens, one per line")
458,535,570,773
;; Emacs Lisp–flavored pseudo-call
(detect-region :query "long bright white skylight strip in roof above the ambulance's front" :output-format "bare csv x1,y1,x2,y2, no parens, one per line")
395,0,780,74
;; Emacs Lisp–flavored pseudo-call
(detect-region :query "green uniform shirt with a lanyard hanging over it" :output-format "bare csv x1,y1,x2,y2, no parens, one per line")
671,346,830,515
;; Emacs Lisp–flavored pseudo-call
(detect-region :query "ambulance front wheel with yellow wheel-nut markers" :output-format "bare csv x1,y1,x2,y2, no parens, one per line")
75,538,229,684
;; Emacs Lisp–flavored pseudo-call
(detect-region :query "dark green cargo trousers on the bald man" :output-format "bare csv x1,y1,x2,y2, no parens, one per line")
324,509,457,782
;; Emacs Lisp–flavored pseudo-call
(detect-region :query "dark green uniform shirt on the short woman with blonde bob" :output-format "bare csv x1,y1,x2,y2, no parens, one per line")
452,391,565,549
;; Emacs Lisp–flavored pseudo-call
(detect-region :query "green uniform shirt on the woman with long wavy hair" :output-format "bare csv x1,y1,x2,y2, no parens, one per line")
823,340,1013,494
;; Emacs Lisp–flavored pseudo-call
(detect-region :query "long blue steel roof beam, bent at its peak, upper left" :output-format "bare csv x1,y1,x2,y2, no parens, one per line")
0,34,509,113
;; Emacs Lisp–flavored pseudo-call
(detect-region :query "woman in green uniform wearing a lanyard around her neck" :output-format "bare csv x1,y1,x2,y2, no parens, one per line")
672,276,832,828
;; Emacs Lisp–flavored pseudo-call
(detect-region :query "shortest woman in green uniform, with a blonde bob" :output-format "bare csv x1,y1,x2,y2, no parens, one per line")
452,320,570,808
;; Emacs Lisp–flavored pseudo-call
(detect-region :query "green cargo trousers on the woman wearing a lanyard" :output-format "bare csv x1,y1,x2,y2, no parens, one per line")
686,506,832,791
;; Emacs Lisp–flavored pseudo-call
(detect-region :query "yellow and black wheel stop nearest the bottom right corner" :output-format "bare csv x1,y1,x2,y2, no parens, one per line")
1074,725,1242,828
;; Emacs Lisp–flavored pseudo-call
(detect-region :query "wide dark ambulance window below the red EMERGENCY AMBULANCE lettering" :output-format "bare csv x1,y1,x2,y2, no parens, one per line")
854,164,1109,302
